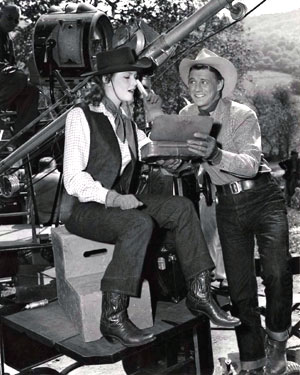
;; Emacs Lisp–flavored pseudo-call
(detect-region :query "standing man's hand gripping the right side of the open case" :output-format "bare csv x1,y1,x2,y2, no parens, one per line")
187,133,222,164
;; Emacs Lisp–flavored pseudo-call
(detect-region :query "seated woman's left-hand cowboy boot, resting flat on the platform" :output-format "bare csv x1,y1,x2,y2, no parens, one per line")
100,292,156,347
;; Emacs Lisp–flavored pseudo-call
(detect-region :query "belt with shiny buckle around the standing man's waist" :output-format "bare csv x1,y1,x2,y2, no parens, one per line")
216,173,271,195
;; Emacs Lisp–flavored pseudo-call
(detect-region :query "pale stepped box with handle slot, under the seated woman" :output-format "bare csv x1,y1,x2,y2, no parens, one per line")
51,225,153,342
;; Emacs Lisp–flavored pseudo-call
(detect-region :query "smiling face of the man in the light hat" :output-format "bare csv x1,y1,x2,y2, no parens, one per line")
188,69,223,109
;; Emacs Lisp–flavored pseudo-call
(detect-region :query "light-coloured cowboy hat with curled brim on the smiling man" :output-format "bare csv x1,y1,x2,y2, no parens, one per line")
179,48,237,98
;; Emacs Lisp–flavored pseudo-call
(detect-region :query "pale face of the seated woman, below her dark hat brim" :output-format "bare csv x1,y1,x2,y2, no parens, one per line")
106,72,137,105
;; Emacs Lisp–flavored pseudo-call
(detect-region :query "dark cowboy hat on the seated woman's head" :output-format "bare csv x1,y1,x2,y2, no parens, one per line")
82,47,152,77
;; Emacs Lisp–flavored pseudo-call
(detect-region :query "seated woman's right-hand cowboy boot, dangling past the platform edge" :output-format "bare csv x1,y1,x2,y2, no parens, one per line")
186,271,241,327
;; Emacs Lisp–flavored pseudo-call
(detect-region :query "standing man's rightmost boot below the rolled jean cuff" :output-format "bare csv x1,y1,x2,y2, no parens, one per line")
266,337,287,375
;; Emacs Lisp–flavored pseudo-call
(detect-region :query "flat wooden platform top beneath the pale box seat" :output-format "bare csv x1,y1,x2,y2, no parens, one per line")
2,301,209,364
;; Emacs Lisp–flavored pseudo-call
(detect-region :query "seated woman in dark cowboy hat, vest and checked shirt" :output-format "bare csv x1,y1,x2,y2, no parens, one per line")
64,47,239,346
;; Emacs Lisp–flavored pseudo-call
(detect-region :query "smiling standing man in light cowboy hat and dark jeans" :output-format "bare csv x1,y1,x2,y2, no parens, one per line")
179,49,292,374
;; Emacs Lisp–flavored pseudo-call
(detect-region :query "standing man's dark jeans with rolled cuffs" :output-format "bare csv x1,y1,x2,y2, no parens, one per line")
217,178,293,370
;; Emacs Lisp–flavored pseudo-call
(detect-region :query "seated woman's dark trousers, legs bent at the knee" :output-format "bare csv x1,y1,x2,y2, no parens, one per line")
66,195,214,296
